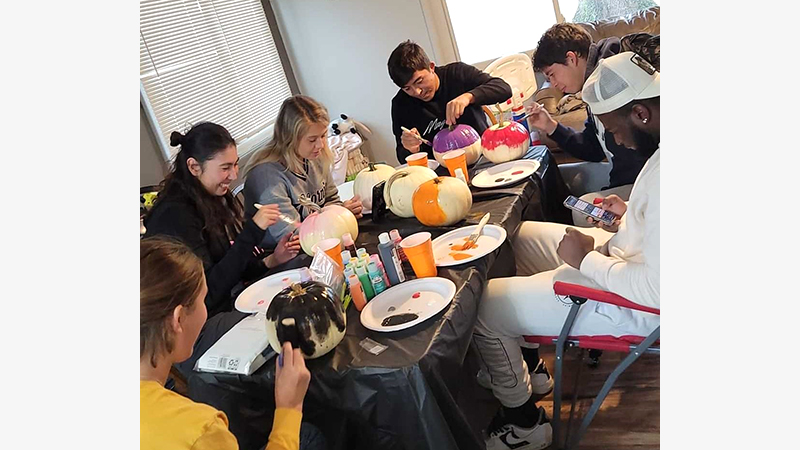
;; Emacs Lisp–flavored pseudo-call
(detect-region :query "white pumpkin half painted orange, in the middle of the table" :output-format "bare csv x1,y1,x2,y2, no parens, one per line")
412,177,472,227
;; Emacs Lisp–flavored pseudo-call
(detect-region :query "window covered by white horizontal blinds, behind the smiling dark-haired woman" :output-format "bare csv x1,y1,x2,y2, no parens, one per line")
139,0,291,158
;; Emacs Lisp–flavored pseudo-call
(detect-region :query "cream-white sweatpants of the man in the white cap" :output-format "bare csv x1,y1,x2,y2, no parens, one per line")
473,222,660,408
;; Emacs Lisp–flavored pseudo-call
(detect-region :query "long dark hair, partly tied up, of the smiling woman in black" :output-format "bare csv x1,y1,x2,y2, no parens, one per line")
150,122,244,241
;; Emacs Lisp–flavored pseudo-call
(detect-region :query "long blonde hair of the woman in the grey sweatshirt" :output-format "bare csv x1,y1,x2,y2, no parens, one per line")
244,95,333,177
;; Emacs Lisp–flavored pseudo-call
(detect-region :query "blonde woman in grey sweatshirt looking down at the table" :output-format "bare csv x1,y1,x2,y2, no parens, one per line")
244,95,362,248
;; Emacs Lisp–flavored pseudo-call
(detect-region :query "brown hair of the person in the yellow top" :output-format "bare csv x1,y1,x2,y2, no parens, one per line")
139,237,205,367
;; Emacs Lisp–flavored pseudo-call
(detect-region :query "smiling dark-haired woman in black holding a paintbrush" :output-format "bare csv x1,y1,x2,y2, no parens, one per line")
145,122,300,319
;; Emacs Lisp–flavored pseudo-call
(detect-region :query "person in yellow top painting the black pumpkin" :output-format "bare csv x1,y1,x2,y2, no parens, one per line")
139,237,324,450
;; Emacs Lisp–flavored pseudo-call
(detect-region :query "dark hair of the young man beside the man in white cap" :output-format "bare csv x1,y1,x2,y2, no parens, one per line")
531,23,592,72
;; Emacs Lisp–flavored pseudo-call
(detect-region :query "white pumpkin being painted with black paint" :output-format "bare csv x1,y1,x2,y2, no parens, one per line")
266,281,347,359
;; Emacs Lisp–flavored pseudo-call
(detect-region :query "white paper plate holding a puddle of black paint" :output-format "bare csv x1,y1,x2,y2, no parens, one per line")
361,277,456,333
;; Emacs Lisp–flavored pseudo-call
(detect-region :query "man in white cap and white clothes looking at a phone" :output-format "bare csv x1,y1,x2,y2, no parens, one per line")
473,52,660,450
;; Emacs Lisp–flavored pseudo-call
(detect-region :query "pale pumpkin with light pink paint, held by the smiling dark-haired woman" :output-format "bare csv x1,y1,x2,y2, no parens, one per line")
299,196,358,256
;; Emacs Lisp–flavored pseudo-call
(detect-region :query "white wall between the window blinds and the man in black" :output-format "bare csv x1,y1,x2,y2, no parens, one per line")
271,0,454,165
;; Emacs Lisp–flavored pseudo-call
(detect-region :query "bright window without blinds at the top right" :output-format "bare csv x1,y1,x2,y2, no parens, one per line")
446,0,661,64
